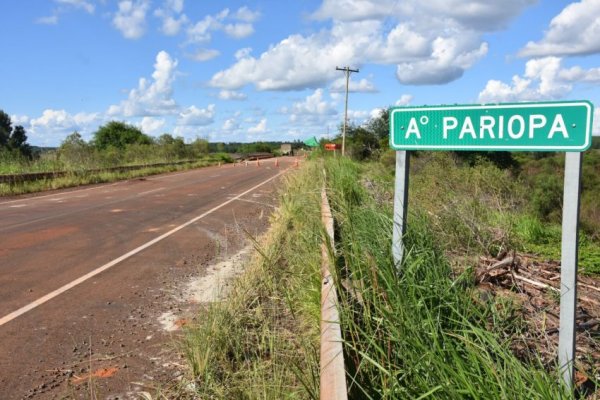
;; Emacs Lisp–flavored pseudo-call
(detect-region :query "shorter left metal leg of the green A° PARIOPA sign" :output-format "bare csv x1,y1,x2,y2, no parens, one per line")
392,151,410,268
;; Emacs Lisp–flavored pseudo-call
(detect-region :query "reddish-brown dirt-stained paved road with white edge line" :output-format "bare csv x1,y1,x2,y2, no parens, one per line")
0,159,294,399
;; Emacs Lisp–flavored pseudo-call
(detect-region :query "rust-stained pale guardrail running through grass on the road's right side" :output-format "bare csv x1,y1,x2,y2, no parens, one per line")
320,187,348,400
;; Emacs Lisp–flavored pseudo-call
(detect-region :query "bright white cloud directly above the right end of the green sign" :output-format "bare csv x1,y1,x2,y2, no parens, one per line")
479,57,600,103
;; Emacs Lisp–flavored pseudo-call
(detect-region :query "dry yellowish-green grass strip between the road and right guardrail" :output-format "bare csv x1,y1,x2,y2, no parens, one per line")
182,159,322,400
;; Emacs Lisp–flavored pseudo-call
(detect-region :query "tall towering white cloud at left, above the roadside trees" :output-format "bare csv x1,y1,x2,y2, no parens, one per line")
108,51,178,117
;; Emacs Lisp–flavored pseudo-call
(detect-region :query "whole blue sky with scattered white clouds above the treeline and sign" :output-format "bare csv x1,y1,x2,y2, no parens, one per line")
0,0,600,146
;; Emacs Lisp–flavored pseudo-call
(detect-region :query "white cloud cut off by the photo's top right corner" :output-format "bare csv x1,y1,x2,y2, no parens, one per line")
519,0,600,57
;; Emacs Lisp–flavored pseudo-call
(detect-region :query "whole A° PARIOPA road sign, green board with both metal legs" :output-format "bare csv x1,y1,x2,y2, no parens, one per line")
390,101,594,390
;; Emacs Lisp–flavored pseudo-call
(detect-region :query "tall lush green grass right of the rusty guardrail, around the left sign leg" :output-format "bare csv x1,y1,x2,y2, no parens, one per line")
327,159,568,399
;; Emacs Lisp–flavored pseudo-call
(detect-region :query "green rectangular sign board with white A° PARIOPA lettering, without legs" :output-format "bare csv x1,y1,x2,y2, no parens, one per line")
390,101,594,152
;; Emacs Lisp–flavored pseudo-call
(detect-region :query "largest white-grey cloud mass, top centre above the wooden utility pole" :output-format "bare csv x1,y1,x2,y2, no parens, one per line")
210,0,534,90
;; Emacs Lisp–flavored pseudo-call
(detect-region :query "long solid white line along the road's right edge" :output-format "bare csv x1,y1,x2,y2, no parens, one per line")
0,167,286,326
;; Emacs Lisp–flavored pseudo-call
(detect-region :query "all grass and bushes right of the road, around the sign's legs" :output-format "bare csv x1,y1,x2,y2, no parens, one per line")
182,108,600,399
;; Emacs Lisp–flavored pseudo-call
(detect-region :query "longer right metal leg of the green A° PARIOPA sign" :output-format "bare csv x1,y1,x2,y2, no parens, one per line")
558,152,582,390
